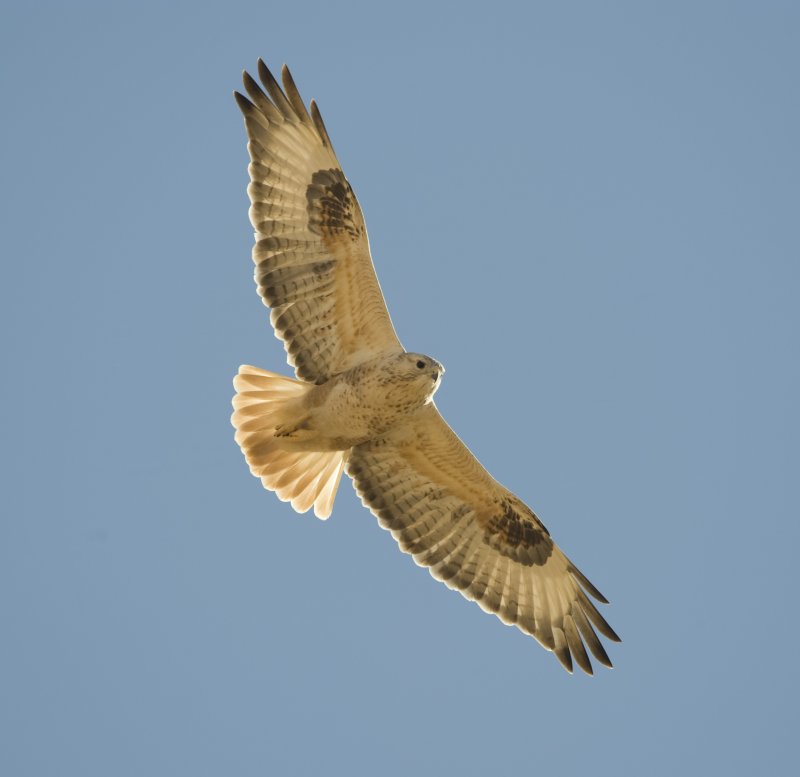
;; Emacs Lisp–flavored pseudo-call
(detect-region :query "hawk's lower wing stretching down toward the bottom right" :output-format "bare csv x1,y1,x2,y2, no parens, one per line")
347,404,619,674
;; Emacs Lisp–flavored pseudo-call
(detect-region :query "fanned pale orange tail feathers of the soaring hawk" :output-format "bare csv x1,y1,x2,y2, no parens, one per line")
231,365,349,519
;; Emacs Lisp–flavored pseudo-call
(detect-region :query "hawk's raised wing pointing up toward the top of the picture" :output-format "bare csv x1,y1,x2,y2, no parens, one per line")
235,60,403,383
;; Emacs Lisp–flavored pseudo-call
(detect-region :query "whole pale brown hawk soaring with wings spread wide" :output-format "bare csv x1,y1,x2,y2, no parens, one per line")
232,60,619,674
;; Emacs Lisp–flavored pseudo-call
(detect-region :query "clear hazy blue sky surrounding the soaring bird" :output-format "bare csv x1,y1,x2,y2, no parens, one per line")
0,0,800,777
